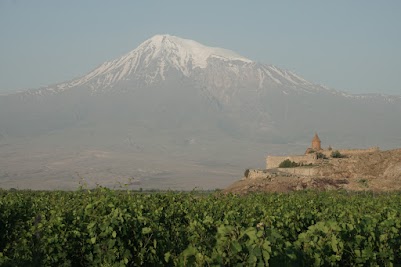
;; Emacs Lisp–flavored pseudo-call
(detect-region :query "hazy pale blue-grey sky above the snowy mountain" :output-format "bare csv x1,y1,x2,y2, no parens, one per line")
0,0,401,95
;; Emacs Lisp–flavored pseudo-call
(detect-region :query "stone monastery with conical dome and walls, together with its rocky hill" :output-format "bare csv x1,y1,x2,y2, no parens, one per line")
234,134,401,192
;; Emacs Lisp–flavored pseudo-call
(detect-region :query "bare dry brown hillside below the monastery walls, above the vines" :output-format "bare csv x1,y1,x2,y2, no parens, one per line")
224,149,401,194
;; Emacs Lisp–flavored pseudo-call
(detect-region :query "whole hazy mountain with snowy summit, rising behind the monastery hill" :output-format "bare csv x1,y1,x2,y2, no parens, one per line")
0,35,401,189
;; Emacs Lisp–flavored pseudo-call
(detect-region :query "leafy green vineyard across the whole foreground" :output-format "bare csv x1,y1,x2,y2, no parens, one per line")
0,188,401,266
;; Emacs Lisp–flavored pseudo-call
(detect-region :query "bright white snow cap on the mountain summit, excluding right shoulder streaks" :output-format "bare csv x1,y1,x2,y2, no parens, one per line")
51,35,252,89
